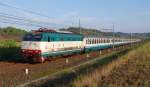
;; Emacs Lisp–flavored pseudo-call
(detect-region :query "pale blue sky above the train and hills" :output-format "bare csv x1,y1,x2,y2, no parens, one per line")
0,0,150,33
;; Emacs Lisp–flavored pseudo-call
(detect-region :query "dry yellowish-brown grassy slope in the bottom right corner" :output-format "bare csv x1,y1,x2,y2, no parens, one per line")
71,42,150,87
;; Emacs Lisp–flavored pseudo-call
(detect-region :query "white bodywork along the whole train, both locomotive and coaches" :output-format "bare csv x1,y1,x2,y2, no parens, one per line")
21,38,140,53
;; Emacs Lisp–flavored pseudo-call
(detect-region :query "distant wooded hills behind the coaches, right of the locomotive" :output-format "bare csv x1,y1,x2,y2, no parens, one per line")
60,27,150,39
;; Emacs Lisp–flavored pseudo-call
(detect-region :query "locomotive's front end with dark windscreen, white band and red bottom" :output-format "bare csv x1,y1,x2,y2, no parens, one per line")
21,34,44,62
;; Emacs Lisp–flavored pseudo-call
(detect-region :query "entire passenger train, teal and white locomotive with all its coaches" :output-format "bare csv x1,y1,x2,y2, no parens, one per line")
21,28,140,63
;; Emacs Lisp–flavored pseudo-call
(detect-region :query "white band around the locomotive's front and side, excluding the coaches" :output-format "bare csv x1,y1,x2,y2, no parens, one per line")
21,41,84,53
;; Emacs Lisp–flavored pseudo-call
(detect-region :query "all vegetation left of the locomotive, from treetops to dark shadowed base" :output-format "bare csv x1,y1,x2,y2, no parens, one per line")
0,27,25,61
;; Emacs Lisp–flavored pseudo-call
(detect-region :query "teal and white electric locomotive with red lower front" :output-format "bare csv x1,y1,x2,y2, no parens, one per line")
21,29,84,62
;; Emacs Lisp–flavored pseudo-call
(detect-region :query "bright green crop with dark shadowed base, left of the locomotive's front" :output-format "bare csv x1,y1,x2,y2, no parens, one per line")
0,40,21,60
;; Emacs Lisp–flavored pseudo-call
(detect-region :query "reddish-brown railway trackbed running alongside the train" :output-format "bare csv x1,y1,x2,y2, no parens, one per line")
0,42,139,87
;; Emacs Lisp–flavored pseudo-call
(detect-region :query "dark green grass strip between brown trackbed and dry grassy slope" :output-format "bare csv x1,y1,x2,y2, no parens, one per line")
29,44,135,87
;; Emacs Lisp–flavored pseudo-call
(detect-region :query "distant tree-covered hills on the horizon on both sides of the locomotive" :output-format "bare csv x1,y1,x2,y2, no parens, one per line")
0,27,150,41
